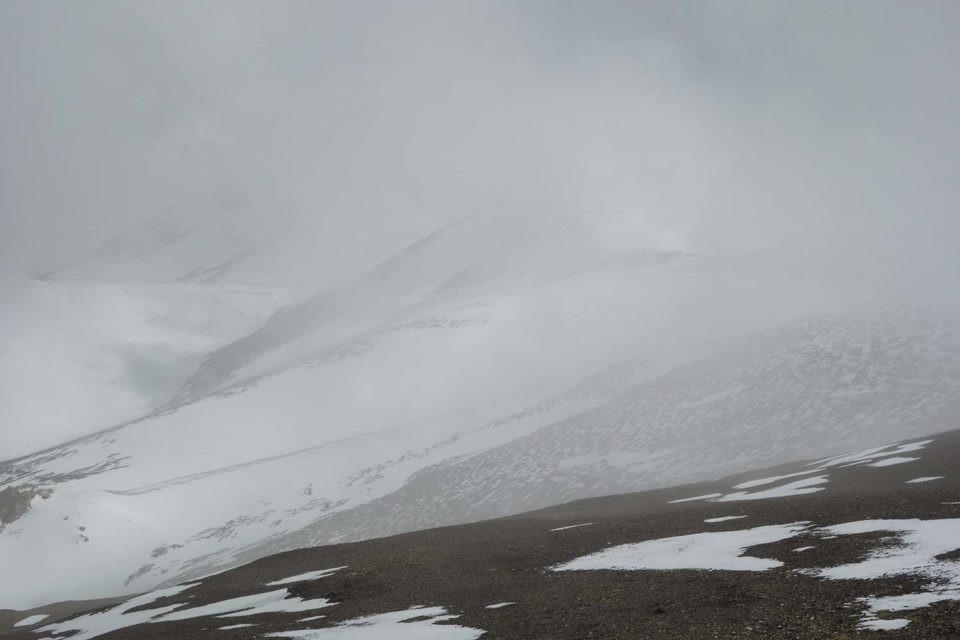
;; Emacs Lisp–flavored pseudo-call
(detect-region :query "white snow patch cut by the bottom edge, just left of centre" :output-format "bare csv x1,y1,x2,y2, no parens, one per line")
267,607,485,640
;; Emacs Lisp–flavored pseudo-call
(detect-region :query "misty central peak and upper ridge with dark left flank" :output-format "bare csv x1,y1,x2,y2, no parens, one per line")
172,213,593,400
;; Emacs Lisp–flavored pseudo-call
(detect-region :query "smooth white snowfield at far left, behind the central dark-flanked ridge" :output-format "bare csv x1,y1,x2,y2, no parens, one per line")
0,278,297,459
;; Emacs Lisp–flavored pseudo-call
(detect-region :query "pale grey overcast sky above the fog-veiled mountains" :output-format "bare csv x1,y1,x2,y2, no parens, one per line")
0,0,960,290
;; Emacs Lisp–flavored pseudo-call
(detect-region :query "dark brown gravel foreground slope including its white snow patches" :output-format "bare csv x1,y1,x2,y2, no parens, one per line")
0,431,960,640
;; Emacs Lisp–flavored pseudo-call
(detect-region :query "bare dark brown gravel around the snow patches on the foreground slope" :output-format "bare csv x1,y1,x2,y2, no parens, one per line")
0,424,960,640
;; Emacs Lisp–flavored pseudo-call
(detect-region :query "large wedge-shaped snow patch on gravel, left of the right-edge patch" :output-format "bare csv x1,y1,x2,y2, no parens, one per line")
552,522,808,571
